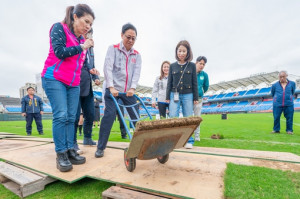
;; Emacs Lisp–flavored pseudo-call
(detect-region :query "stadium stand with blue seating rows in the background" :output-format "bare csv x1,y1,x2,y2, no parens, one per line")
0,72,300,115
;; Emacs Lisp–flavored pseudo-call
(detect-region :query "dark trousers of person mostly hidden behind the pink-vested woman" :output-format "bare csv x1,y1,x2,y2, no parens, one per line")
74,91,95,143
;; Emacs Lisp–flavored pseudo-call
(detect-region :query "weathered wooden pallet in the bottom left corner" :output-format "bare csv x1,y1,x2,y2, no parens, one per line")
0,161,55,198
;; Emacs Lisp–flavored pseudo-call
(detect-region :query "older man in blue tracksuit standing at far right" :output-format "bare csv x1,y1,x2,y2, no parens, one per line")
271,71,296,135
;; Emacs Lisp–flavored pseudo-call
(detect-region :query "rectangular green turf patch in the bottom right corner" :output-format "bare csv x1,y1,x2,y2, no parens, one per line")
224,163,300,199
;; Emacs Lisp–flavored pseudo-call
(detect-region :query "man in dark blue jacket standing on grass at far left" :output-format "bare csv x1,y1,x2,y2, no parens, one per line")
21,87,44,135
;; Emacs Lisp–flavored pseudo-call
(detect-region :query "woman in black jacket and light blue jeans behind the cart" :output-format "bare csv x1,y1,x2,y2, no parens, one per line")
166,40,198,148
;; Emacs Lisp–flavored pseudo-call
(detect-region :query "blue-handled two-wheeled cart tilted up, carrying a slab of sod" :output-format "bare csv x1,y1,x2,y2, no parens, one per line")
110,93,202,172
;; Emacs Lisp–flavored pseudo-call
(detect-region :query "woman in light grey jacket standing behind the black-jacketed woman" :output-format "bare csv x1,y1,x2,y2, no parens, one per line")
152,61,171,118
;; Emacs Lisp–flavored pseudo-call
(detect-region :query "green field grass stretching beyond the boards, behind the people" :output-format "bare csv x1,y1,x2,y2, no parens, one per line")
0,112,300,155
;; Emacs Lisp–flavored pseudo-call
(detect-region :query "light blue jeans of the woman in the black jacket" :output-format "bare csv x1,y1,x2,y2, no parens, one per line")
169,92,195,144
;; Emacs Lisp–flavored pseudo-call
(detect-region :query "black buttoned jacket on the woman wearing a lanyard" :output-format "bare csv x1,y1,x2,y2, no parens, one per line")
166,62,198,101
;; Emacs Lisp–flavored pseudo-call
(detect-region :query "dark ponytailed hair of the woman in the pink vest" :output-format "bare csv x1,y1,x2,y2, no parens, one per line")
62,4,95,30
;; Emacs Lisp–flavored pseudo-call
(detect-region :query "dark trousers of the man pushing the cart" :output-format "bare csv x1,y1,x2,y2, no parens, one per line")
97,88,139,150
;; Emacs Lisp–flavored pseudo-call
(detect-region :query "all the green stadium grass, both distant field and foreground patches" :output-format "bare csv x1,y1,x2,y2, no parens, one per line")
0,112,300,198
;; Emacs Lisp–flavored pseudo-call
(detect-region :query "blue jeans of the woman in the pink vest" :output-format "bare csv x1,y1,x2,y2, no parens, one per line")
42,78,80,153
